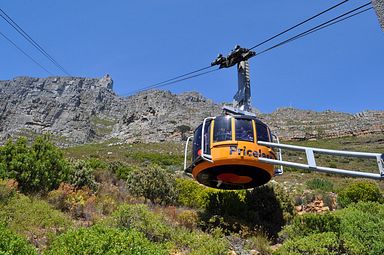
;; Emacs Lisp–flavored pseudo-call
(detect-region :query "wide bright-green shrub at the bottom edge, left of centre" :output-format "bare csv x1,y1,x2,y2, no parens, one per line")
45,225,169,255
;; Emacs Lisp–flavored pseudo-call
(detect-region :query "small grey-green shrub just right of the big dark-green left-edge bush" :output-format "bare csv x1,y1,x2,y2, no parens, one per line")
68,159,97,190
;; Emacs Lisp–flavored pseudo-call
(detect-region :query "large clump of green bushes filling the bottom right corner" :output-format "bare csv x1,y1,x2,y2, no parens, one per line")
276,202,384,255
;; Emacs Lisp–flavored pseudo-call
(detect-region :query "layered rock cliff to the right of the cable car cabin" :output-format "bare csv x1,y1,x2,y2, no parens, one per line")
260,108,384,140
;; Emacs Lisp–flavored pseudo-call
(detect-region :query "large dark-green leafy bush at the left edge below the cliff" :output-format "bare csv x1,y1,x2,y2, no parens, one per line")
0,136,69,192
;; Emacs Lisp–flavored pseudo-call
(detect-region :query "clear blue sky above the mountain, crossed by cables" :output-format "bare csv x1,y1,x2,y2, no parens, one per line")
0,0,384,113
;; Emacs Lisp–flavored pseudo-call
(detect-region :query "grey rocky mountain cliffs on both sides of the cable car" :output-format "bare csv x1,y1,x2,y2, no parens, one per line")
0,75,384,145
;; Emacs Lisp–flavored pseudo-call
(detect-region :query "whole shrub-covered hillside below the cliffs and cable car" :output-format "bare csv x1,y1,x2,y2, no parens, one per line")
0,134,384,255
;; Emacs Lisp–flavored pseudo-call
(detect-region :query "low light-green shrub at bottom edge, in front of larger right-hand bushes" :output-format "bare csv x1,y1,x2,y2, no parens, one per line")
273,232,341,255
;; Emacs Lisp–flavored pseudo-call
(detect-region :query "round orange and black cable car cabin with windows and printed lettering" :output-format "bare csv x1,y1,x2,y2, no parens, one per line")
185,115,277,189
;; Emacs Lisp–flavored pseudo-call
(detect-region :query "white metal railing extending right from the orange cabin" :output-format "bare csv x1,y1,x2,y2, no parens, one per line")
258,141,384,180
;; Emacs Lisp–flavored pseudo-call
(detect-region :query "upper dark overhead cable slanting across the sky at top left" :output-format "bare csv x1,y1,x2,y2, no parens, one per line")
0,8,71,76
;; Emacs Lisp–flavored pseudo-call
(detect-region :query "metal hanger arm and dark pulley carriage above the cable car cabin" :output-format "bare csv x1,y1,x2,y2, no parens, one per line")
211,45,256,116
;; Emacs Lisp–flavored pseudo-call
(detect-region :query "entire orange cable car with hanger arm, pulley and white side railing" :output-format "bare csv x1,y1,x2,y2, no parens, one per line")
184,46,384,189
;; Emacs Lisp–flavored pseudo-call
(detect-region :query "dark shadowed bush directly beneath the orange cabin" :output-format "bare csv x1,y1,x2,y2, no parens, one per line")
201,181,294,237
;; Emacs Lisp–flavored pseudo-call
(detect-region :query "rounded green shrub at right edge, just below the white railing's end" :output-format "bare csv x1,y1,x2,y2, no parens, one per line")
338,181,383,207
